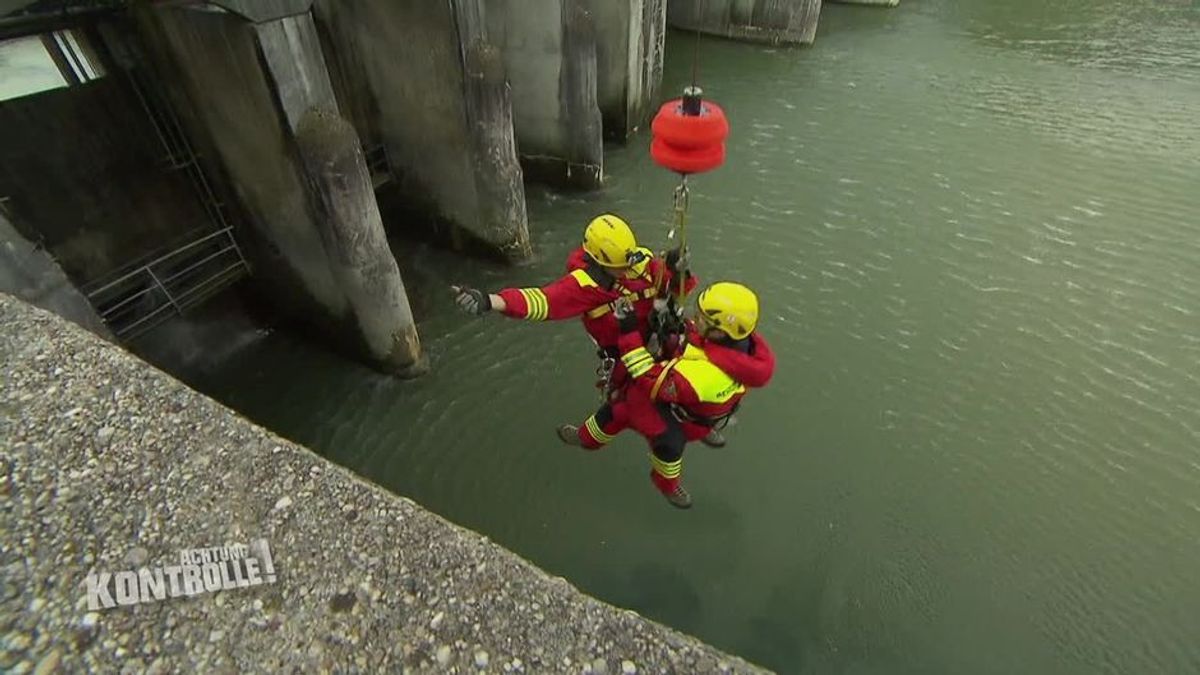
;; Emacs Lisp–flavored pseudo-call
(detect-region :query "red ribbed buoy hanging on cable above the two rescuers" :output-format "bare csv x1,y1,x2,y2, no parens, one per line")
650,86,730,174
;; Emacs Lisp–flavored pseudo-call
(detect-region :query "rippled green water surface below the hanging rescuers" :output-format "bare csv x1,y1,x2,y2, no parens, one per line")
180,0,1200,674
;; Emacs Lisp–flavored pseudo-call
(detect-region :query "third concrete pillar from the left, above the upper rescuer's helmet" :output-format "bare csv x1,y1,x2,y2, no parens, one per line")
486,0,604,189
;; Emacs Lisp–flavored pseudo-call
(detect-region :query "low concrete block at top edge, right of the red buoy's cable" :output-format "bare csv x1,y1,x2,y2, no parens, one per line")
667,0,821,44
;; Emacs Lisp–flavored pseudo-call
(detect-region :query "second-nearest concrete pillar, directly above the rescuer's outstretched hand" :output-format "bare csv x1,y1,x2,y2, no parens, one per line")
313,0,532,261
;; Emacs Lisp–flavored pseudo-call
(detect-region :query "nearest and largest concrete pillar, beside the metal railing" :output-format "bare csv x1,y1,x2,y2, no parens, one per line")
140,0,420,375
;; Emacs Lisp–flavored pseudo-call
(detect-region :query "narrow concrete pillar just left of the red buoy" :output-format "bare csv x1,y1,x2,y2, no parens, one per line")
587,0,667,141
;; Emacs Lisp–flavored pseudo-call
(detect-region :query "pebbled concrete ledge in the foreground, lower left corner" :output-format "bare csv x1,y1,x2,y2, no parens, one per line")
0,295,758,673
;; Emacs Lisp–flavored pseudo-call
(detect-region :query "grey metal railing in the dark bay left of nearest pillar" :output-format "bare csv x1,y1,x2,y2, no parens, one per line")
84,227,250,340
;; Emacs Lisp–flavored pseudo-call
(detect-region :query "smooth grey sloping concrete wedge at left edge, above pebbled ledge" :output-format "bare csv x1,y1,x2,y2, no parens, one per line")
0,213,113,340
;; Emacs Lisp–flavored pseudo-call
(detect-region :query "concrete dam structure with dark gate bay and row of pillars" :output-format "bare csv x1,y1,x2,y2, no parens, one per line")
0,0,686,376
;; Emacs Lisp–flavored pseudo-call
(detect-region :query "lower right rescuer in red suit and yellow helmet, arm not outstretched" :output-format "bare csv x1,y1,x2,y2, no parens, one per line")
558,281,775,508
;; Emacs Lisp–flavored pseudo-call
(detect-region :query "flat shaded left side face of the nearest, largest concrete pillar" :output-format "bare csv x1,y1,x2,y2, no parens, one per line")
139,4,348,318
